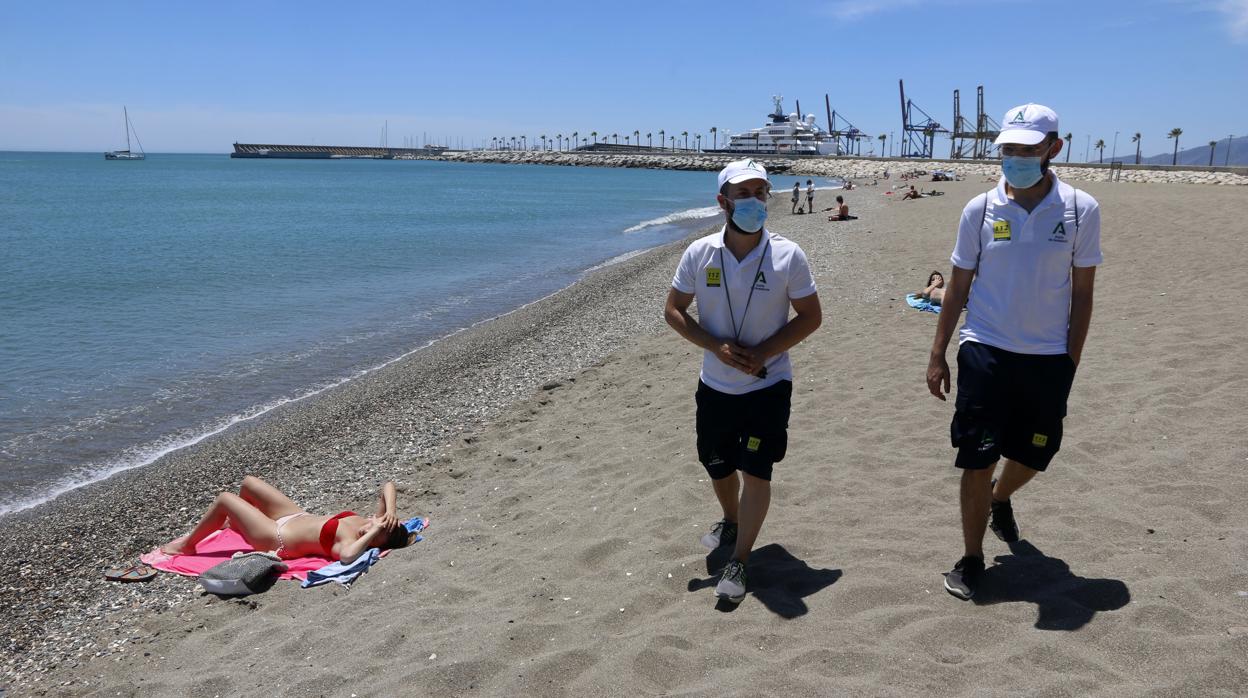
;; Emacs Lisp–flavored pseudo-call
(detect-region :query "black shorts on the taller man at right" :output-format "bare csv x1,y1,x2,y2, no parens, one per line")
950,342,1075,471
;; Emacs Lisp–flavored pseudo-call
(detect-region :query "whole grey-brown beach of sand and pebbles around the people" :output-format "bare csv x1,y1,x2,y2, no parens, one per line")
0,174,1248,697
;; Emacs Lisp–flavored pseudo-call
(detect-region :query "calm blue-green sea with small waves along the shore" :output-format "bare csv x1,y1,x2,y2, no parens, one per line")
0,152,840,514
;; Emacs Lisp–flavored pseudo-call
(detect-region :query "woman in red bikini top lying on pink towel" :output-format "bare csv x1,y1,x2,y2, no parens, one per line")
161,476,416,564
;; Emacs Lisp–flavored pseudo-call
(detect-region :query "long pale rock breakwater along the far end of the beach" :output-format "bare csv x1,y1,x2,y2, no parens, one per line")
419,150,1248,186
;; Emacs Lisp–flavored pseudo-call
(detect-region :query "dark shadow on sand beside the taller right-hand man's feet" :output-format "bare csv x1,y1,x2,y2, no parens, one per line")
973,541,1131,631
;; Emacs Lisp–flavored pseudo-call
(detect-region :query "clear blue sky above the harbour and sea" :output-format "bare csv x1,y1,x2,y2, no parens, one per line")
0,0,1248,160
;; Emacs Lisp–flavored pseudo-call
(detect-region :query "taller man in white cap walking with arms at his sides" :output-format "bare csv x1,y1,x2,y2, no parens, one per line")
927,104,1102,599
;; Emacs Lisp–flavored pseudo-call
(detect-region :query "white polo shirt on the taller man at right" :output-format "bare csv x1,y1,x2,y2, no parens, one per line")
950,170,1103,355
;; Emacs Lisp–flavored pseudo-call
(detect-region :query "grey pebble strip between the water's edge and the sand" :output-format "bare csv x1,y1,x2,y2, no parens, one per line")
0,231,705,696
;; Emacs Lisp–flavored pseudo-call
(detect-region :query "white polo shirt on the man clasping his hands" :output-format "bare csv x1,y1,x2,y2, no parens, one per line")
671,229,815,395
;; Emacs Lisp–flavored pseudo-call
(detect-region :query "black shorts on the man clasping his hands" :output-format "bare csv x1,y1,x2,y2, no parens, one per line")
695,381,792,481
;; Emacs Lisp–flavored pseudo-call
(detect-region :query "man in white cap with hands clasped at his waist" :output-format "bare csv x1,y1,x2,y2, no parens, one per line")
664,160,822,603
